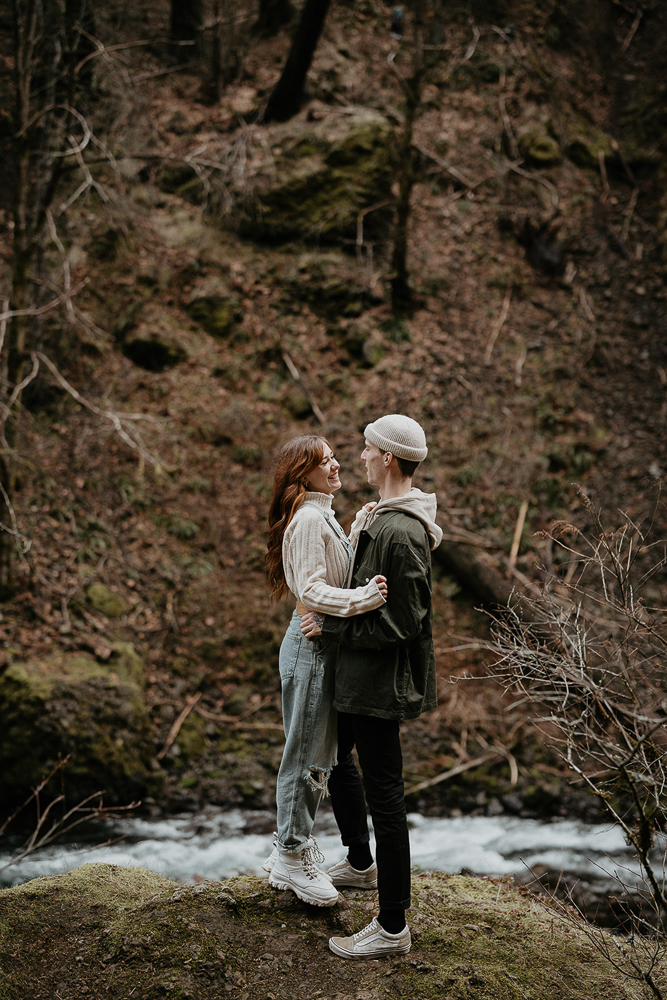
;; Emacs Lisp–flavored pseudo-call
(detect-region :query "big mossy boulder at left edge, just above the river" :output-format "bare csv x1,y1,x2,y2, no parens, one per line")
0,642,154,802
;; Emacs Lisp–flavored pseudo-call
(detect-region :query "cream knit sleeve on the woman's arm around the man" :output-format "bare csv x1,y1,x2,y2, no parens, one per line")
283,515,384,618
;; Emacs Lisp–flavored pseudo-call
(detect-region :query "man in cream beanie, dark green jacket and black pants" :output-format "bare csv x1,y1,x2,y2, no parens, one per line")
301,413,442,958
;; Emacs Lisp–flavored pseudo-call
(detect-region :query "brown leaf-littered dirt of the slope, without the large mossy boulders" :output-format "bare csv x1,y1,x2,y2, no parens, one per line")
0,3,667,814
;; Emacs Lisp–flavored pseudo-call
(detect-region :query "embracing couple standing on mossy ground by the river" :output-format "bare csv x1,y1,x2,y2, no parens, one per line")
264,414,442,958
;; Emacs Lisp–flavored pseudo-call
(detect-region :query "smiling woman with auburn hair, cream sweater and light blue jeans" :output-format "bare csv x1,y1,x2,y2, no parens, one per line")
264,435,387,906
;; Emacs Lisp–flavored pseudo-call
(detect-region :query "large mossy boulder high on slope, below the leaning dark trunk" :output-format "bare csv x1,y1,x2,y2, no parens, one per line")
242,109,395,241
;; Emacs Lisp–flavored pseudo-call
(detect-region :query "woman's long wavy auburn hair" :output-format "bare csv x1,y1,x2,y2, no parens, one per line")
264,434,330,601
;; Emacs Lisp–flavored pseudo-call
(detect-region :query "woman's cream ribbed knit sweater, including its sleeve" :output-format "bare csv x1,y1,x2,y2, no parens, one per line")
283,493,385,618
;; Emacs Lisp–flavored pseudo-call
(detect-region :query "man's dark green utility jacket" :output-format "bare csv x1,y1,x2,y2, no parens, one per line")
322,510,437,721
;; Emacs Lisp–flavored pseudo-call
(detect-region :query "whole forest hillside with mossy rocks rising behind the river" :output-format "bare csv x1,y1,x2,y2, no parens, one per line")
0,0,667,816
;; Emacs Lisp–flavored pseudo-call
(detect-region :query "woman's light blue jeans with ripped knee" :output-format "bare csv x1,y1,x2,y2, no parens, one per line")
276,611,338,854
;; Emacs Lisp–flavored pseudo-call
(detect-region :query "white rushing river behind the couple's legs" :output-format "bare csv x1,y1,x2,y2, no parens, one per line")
0,808,648,890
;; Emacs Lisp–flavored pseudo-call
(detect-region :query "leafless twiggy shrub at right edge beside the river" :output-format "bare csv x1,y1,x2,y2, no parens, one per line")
491,495,667,997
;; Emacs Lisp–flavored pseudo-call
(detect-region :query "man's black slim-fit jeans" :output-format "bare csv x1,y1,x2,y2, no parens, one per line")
329,712,410,910
